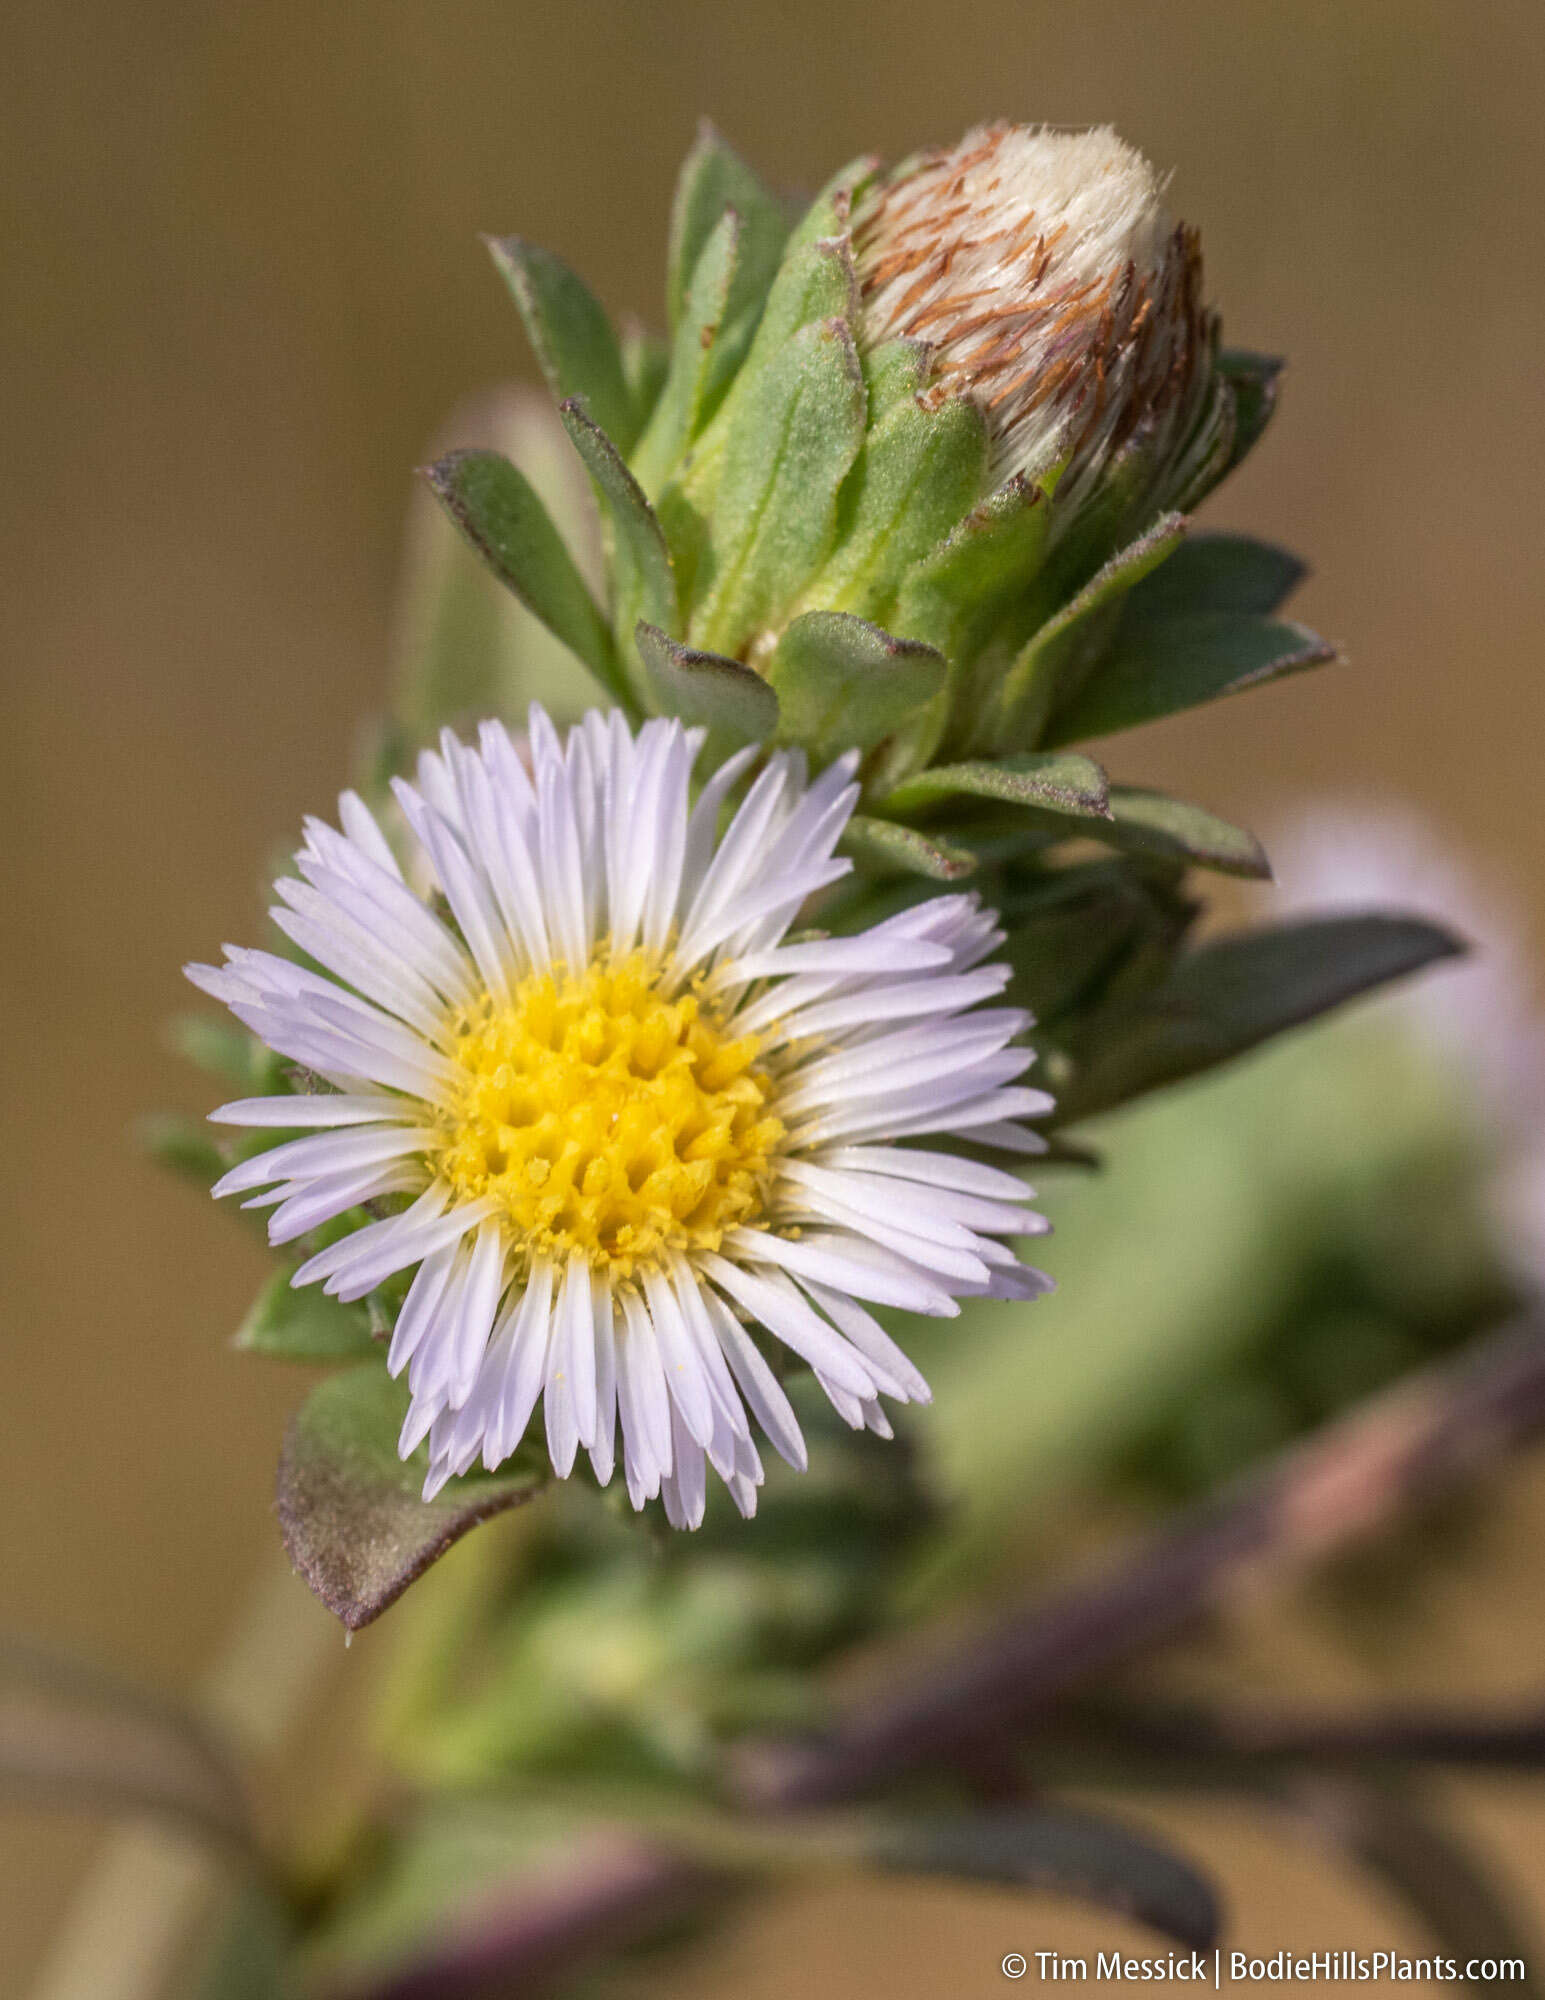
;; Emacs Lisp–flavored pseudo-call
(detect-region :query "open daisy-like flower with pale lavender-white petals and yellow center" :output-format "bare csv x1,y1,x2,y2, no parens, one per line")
188,708,1051,1526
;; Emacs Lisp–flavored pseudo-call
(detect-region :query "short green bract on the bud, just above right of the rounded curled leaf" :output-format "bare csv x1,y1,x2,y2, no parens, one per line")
891,472,1051,660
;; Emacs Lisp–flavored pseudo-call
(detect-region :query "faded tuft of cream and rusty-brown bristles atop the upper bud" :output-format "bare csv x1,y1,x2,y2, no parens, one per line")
853,124,1207,528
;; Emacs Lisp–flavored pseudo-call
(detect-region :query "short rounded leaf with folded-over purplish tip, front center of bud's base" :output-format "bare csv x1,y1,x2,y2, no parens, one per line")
766,612,949,762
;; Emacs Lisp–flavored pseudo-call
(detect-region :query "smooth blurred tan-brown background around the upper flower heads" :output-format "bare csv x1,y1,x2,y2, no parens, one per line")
0,0,1545,1992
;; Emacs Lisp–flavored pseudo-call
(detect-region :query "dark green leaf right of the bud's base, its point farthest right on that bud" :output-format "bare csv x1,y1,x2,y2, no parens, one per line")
1045,612,1337,744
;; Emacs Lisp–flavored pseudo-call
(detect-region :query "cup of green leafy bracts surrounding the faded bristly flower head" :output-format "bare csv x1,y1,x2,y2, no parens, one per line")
428,128,1331,876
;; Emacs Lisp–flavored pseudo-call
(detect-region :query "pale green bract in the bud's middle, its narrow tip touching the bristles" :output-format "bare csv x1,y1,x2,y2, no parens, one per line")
796,342,987,624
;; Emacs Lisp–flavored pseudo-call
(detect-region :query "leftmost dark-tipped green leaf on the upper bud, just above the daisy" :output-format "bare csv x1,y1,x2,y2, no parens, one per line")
424,452,632,706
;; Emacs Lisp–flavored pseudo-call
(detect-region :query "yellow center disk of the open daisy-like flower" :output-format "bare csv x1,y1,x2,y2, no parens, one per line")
438,952,783,1278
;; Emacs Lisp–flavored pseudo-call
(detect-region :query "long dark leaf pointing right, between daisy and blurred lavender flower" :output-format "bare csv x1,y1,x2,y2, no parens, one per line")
1057,912,1465,1124
